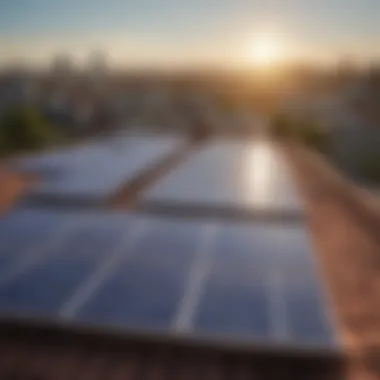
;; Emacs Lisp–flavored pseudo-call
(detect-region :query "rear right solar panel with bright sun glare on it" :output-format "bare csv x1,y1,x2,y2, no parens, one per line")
142,141,302,218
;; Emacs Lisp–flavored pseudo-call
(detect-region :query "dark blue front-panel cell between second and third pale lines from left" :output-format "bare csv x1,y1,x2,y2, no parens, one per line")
78,221,201,328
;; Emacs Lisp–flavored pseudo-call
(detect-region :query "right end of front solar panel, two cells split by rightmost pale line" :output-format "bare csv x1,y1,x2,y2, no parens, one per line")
194,224,336,347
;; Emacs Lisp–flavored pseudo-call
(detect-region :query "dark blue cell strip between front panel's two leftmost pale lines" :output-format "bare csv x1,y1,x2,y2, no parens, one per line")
0,224,127,315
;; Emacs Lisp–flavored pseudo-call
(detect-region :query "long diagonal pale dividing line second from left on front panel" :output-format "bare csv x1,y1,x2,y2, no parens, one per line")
59,220,149,319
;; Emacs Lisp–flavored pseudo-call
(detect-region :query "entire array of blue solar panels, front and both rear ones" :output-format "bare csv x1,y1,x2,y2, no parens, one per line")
0,136,339,349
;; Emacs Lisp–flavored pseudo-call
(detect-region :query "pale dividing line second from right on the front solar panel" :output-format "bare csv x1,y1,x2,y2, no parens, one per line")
173,224,217,331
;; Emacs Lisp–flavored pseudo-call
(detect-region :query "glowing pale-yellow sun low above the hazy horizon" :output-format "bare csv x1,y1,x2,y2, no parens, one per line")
248,35,283,67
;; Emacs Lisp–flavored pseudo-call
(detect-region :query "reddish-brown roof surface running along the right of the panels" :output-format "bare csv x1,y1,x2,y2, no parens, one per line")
285,146,380,380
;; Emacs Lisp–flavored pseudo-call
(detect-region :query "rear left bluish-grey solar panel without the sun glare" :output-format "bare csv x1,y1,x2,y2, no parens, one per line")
14,136,178,201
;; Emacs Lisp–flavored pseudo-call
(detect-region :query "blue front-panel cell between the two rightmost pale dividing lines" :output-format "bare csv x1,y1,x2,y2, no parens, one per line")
195,225,271,339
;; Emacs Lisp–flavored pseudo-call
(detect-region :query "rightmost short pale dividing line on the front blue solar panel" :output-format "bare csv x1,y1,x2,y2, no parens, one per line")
266,268,289,341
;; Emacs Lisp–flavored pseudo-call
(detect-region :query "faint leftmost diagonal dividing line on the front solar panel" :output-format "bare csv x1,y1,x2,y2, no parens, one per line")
0,216,81,286
